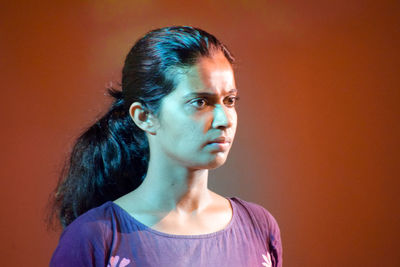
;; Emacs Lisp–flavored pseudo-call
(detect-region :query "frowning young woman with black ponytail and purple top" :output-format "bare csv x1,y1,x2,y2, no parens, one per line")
50,27,282,267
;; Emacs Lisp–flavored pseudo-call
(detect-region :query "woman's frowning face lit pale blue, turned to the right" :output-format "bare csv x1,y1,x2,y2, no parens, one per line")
151,53,237,169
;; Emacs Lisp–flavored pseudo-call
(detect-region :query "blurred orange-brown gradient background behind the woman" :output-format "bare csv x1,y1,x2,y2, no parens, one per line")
0,0,400,266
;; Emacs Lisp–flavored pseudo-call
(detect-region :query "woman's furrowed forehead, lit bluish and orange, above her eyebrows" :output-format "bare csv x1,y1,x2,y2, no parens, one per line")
175,53,236,96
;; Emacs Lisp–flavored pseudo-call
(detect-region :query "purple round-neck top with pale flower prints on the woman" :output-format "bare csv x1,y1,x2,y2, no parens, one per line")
50,197,282,267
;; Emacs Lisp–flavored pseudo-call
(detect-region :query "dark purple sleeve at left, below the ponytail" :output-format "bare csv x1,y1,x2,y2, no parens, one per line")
50,220,106,267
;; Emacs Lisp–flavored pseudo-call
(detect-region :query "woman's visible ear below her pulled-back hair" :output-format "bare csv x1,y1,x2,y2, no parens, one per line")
129,102,158,135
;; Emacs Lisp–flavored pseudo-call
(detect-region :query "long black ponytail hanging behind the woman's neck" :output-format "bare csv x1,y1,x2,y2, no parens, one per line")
54,89,149,227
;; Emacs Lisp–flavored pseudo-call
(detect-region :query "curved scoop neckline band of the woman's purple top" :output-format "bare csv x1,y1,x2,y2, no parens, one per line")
109,198,237,239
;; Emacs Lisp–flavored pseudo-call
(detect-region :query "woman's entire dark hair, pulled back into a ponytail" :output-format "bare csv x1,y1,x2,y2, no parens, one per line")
52,26,234,227
